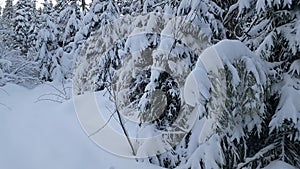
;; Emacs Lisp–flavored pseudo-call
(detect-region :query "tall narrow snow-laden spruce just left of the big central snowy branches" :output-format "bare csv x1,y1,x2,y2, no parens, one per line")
54,0,83,78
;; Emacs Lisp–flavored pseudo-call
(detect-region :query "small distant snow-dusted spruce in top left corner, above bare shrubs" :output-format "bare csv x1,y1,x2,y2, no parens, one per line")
12,0,35,56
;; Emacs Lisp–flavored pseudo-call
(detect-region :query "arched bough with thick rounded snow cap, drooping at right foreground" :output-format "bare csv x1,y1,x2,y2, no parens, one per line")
179,40,267,169
